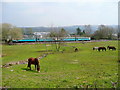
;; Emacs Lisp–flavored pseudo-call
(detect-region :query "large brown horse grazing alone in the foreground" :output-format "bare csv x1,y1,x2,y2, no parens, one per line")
28,58,40,72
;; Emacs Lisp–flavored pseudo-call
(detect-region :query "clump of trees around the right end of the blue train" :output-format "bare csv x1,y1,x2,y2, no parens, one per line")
76,25,118,40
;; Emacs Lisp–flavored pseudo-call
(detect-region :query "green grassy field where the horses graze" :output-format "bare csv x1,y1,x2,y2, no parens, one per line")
2,41,118,88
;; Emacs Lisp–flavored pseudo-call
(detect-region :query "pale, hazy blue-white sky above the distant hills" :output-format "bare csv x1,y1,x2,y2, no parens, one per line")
0,0,119,27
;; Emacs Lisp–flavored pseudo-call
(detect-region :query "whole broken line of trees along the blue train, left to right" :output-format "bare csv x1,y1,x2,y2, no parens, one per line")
0,23,118,42
